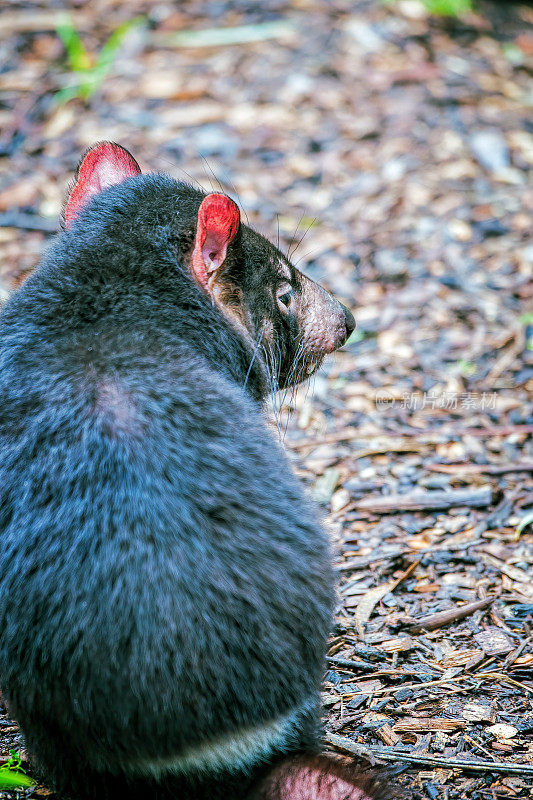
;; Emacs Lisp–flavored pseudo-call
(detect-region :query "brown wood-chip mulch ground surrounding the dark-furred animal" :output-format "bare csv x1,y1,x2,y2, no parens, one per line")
0,0,533,800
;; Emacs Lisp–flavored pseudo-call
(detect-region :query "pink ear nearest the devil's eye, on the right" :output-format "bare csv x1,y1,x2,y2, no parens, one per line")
192,194,241,288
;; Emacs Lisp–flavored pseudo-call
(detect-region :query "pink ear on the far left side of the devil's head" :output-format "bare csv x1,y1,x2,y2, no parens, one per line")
65,142,141,228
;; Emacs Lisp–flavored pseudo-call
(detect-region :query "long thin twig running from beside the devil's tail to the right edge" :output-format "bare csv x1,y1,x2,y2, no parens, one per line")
324,733,533,775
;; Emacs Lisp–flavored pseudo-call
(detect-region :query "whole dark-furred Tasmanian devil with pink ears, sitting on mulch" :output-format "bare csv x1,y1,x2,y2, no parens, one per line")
0,142,384,800
